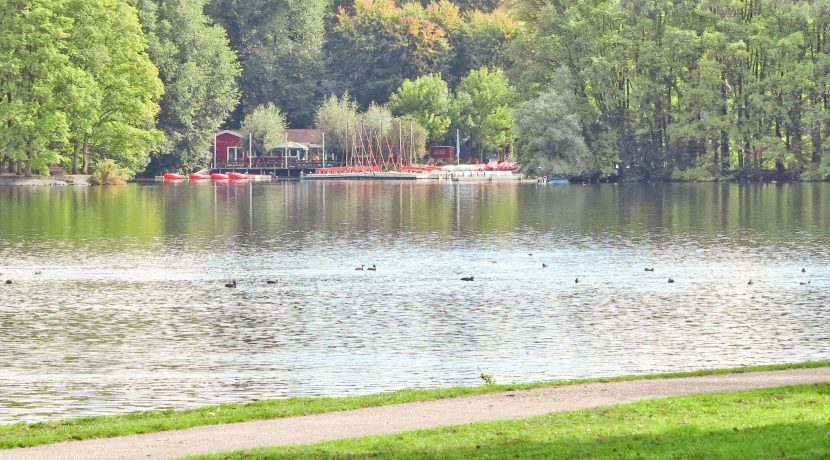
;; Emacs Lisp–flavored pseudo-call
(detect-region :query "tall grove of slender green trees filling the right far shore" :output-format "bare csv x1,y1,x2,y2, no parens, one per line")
512,0,830,178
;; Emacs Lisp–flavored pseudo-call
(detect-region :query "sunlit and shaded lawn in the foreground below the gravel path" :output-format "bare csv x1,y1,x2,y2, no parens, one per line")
193,384,830,459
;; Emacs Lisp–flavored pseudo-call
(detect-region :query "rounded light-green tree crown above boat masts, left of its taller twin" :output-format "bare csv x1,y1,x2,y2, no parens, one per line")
389,74,452,140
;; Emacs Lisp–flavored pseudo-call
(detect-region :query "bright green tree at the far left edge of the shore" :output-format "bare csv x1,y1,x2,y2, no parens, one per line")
0,0,75,175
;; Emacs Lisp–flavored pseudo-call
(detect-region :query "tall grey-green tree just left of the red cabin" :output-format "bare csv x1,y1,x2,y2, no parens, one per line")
131,0,241,170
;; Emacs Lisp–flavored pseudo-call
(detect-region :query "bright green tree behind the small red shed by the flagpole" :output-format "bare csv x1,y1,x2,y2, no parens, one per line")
453,67,515,160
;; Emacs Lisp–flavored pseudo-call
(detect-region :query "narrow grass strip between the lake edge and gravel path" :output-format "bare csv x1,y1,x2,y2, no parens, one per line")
0,361,830,449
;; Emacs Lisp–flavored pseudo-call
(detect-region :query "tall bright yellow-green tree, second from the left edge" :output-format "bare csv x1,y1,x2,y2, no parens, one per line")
65,0,163,174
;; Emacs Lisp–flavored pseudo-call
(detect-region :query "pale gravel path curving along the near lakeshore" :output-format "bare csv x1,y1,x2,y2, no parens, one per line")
0,367,830,460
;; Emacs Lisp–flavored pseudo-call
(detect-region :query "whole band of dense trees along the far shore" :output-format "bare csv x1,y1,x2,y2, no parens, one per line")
0,0,830,180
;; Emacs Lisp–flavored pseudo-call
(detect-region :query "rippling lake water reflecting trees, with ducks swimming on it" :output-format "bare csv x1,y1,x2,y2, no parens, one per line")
0,182,830,423
